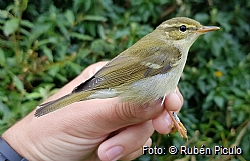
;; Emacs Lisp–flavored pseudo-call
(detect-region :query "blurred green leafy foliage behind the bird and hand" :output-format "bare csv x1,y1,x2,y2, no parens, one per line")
0,0,250,161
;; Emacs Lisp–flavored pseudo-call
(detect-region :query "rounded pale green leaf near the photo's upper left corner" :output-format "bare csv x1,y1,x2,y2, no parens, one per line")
3,18,19,36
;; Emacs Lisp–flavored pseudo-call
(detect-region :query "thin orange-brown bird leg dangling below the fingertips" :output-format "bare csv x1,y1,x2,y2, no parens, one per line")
167,110,188,139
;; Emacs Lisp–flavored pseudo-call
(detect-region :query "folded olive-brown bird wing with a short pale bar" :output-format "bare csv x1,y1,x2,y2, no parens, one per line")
72,45,181,93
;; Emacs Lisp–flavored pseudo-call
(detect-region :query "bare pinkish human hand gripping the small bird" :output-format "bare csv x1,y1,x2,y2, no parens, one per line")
2,62,183,161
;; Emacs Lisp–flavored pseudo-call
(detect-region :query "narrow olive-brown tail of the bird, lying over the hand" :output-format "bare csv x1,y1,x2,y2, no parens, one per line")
35,91,91,117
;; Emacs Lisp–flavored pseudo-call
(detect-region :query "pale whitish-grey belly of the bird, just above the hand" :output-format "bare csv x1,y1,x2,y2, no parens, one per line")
117,70,181,104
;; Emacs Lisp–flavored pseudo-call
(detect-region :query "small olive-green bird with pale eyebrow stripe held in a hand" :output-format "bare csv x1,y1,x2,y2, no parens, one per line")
35,17,219,137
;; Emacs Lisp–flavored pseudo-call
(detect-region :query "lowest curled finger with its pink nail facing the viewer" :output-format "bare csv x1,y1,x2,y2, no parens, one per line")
98,121,154,160
